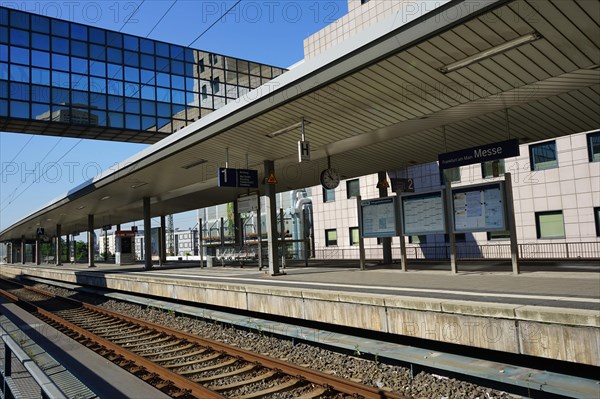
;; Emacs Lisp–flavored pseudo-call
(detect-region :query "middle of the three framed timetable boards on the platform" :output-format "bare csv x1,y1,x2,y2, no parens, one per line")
401,191,446,236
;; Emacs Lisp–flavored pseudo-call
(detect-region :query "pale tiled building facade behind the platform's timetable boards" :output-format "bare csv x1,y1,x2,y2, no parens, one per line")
311,131,600,255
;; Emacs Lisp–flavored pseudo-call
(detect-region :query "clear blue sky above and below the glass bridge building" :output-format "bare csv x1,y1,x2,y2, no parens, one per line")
0,0,347,231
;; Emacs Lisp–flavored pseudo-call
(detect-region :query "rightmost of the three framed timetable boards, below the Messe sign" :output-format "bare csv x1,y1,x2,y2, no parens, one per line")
452,183,506,233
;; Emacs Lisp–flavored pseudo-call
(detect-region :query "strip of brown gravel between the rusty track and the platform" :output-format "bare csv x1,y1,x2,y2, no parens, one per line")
30,284,518,399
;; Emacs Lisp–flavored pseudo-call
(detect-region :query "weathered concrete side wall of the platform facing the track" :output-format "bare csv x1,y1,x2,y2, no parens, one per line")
1,265,600,366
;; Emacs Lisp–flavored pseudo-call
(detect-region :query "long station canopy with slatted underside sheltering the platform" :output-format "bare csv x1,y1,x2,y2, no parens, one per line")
0,0,600,240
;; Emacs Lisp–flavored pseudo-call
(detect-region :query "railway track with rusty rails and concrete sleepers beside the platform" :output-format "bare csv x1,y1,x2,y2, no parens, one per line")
0,280,408,399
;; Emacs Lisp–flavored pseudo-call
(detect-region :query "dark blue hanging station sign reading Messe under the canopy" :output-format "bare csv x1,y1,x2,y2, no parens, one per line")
438,139,519,169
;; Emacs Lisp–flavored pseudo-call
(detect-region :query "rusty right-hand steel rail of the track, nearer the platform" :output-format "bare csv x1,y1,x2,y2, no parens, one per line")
5,286,410,399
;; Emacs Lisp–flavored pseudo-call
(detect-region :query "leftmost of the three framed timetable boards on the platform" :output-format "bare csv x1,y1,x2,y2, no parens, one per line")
360,197,399,238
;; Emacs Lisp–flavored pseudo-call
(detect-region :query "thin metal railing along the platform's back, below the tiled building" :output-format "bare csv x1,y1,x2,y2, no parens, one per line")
315,242,600,260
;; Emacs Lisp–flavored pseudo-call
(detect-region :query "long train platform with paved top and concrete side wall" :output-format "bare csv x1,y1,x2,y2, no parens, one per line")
0,261,600,366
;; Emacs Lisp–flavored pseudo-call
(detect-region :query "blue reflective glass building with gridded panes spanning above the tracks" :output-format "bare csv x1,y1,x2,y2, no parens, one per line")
0,7,285,143
